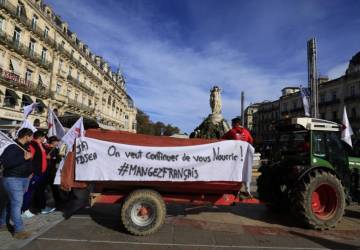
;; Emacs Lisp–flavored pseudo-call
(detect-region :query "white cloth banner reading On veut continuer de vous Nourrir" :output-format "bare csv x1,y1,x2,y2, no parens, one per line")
75,137,254,182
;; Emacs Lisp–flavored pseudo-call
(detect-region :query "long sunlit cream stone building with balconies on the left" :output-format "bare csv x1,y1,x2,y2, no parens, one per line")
0,0,137,132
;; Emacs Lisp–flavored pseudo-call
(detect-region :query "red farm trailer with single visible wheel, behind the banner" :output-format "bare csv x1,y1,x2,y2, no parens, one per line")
61,129,259,236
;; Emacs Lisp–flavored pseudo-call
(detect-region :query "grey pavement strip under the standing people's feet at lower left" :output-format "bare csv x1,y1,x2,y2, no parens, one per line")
0,212,63,250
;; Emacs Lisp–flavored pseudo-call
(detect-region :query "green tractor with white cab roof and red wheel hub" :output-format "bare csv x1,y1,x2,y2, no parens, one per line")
257,117,360,230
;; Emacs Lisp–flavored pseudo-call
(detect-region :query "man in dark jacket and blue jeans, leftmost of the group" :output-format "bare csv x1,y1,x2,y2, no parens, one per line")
0,128,33,239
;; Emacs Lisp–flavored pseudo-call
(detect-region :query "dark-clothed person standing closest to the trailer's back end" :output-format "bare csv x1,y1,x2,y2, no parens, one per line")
46,136,62,209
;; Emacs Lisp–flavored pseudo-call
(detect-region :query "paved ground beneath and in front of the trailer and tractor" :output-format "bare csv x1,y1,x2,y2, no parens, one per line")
16,204,360,250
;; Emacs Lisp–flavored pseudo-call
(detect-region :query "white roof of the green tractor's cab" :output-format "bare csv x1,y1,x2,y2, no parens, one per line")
291,117,341,131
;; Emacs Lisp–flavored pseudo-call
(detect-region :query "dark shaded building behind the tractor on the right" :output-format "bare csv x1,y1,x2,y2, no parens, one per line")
253,52,360,144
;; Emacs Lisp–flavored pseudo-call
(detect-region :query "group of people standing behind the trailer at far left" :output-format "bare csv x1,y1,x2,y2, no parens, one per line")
0,128,63,239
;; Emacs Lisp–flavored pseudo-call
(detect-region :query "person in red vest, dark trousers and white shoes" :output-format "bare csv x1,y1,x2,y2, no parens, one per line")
23,131,55,217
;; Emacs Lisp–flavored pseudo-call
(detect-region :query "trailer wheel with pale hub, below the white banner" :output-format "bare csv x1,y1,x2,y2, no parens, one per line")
121,189,166,236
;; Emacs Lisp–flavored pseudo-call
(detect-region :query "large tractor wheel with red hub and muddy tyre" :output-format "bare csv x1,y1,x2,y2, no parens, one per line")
292,170,345,230
